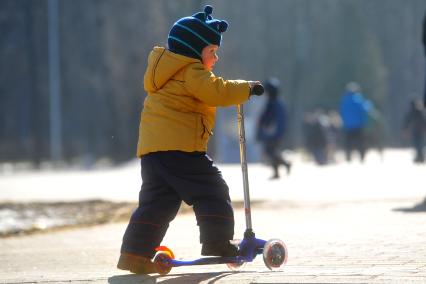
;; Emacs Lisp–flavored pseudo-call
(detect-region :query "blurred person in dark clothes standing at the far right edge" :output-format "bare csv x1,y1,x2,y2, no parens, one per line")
404,99,426,163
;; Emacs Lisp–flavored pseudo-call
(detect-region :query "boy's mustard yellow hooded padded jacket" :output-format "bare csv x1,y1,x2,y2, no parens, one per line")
137,46,250,157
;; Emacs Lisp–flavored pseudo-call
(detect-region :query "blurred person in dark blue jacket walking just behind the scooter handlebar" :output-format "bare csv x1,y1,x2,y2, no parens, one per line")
257,78,291,179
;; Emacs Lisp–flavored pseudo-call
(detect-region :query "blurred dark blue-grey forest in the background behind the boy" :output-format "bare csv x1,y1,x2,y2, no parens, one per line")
0,0,426,165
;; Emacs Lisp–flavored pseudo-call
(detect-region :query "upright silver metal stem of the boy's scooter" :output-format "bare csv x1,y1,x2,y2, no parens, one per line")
237,104,252,232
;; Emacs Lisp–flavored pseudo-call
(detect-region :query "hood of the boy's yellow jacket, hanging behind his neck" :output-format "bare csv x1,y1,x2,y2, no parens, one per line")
144,46,201,92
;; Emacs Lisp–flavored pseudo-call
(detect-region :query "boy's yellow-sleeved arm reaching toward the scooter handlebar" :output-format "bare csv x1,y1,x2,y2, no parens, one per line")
185,64,250,106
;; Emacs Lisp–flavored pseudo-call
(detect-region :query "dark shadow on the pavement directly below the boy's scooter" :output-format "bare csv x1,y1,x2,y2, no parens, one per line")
108,272,238,284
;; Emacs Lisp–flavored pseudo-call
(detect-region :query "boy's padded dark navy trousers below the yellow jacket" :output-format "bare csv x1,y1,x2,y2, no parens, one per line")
121,151,234,258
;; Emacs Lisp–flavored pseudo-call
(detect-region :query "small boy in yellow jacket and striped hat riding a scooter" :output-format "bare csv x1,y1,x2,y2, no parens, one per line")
117,6,259,274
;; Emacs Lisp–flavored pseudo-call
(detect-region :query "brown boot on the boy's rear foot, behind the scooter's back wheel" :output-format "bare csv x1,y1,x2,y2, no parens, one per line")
117,253,157,274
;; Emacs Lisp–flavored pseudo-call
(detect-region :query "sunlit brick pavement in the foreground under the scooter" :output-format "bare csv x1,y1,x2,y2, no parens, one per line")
0,198,426,284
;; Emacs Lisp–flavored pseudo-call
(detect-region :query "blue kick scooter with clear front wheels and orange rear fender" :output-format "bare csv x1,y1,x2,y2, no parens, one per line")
154,85,288,275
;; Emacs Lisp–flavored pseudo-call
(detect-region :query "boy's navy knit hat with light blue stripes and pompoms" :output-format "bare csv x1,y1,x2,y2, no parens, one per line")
167,5,228,60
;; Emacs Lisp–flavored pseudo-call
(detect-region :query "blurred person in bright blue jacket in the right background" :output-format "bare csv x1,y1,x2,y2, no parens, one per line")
340,82,369,162
